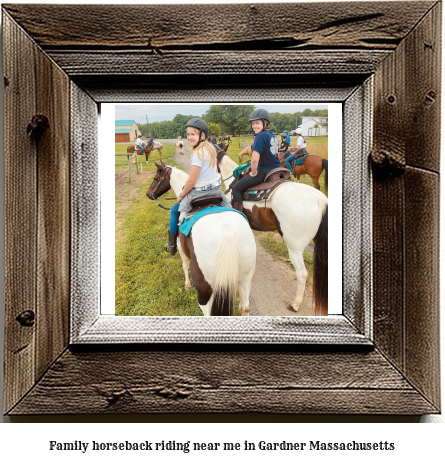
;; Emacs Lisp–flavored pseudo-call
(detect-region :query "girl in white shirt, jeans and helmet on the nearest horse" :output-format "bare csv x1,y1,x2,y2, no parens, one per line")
165,118,230,255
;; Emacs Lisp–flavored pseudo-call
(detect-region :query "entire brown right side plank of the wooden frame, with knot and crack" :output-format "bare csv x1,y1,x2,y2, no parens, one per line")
372,4,441,405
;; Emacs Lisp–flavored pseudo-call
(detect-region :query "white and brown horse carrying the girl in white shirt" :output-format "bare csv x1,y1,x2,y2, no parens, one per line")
147,162,256,316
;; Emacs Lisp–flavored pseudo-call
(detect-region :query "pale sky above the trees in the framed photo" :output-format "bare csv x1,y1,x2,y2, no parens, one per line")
115,103,328,123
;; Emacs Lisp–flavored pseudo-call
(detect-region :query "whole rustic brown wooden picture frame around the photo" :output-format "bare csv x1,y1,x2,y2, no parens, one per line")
2,1,441,415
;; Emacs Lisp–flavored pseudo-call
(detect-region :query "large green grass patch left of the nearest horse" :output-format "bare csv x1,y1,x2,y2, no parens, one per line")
115,144,202,316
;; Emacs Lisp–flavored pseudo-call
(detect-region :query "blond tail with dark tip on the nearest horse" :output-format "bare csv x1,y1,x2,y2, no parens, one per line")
210,232,241,316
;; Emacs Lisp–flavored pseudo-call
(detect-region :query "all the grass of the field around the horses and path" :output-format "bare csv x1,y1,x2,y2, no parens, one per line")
115,138,327,316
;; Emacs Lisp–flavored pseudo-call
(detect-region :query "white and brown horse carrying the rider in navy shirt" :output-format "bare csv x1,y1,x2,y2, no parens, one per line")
218,150,328,315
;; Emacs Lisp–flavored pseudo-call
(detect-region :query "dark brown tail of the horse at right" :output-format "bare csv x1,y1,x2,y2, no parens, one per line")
313,205,328,316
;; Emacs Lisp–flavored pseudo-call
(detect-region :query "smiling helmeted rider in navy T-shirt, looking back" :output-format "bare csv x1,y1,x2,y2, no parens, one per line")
232,109,281,212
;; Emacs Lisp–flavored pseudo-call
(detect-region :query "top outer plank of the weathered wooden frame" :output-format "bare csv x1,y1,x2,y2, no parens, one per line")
4,1,435,49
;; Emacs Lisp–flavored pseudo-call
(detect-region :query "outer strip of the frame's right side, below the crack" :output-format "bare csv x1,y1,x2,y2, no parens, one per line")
405,168,440,406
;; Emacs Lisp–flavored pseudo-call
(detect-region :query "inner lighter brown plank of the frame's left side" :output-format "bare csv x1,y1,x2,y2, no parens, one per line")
35,34,71,378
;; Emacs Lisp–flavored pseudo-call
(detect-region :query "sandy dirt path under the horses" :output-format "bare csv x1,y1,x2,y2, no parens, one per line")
175,141,314,316
